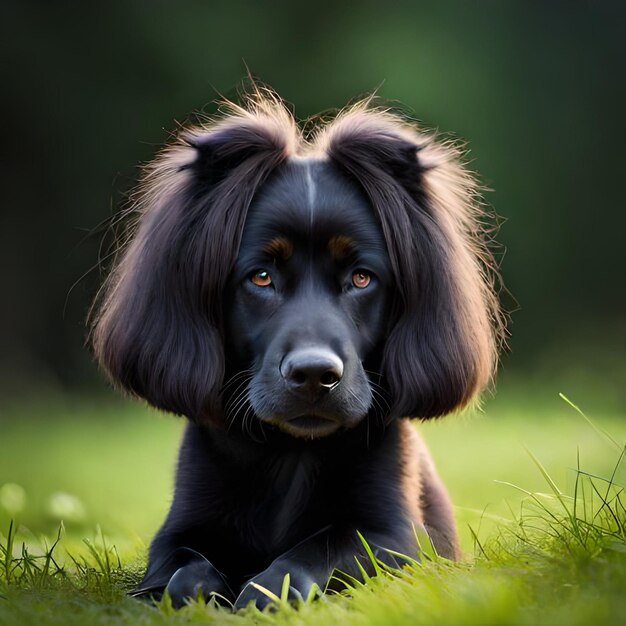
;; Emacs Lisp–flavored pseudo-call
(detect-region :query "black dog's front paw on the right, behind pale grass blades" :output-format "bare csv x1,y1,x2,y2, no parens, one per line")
234,561,319,611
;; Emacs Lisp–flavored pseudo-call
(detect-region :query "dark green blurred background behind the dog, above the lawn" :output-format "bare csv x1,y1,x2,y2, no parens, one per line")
0,0,626,399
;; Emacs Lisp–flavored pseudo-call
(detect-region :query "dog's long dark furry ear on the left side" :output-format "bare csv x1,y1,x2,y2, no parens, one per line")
90,102,294,421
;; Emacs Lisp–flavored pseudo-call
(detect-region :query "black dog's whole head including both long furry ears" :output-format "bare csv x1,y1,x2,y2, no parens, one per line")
92,93,502,437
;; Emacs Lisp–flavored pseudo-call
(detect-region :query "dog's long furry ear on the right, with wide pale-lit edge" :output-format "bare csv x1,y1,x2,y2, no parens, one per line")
322,107,503,418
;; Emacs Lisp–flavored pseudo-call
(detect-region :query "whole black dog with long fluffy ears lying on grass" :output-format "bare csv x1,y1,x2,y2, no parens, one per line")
92,91,502,607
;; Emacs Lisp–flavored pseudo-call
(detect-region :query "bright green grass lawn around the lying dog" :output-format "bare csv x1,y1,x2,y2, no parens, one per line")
0,390,626,626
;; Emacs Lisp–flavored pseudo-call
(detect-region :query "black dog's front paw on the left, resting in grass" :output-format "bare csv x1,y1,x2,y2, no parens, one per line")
165,560,232,609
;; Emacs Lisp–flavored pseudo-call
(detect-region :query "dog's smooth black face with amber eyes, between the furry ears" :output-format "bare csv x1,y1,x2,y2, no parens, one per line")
225,159,392,438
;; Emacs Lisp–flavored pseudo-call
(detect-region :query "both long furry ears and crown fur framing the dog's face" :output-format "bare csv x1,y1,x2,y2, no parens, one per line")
90,87,503,421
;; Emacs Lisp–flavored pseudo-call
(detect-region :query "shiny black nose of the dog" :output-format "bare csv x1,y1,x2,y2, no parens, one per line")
280,348,343,398
